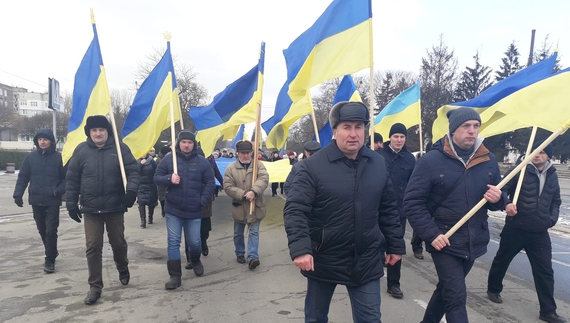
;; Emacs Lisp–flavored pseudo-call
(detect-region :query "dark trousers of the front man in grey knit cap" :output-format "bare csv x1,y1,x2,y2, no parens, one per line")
422,251,474,323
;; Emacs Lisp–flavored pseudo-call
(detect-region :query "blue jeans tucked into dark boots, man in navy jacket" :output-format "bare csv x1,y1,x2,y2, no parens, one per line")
166,213,202,260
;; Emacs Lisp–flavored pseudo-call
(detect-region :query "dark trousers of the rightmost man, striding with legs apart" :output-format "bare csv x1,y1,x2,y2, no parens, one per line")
487,226,556,315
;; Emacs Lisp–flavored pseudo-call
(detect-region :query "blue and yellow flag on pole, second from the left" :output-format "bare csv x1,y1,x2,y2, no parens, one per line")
122,41,180,158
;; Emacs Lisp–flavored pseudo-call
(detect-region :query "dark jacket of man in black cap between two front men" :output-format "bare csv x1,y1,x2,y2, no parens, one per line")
376,141,416,208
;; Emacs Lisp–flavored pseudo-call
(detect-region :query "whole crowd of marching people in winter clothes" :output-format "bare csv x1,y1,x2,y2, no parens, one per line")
13,102,566,323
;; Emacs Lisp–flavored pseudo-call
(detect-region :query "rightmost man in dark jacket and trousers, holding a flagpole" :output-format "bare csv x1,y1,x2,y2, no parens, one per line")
487,141,566,323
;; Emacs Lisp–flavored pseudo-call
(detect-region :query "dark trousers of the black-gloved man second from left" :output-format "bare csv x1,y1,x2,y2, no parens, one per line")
83,212,129,292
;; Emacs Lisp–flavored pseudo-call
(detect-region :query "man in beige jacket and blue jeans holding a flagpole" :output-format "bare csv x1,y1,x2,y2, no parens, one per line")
224,141,269,270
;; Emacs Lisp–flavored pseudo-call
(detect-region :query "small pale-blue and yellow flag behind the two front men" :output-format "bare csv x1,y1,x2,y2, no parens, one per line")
374,80,421,138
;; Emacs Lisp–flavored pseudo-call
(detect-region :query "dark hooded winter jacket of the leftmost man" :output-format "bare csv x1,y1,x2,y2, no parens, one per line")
13,129,66,206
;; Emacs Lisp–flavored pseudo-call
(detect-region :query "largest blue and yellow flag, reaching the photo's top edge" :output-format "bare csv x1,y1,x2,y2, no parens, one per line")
263,0,372,148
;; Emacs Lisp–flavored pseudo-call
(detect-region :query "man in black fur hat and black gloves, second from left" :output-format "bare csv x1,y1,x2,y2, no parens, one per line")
66,115,140,305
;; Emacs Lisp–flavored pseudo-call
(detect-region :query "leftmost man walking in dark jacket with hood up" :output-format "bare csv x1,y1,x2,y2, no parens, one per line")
13,129,66,273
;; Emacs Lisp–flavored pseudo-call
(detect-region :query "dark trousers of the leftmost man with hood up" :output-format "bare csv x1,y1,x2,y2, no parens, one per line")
32,205,59,262
